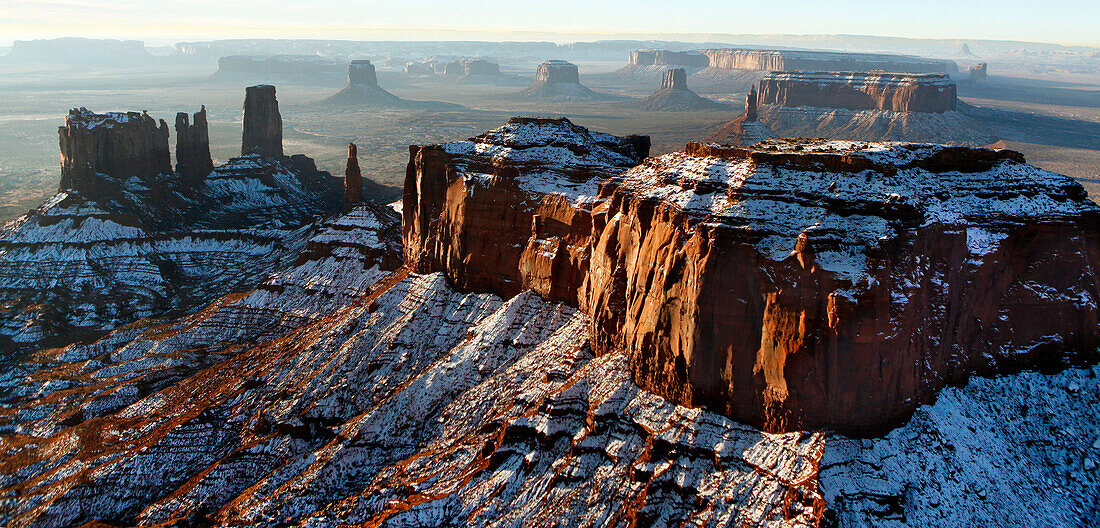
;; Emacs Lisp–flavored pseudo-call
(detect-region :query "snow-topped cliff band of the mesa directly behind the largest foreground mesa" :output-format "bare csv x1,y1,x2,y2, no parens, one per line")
759,72,957,113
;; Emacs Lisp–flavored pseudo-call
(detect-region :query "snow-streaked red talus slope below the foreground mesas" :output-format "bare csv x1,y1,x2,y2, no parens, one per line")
0,154,1100,528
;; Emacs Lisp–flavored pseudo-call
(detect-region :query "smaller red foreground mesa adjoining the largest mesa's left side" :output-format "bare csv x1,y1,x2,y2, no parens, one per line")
402,118,649,305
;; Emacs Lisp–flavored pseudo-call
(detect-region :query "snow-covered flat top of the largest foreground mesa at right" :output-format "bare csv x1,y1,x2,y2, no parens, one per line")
616,140,1100,283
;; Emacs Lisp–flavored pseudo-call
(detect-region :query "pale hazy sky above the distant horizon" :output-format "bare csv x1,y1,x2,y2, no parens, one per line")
0,0,1100,45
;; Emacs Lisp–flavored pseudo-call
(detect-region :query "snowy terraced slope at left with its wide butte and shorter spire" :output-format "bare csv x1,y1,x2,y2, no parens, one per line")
0,91,342,349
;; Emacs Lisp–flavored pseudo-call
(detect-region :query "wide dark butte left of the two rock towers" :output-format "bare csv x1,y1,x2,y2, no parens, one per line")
57,108,172,198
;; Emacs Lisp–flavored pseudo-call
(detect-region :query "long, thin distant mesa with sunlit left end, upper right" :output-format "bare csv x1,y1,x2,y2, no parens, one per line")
700,48,958,74
